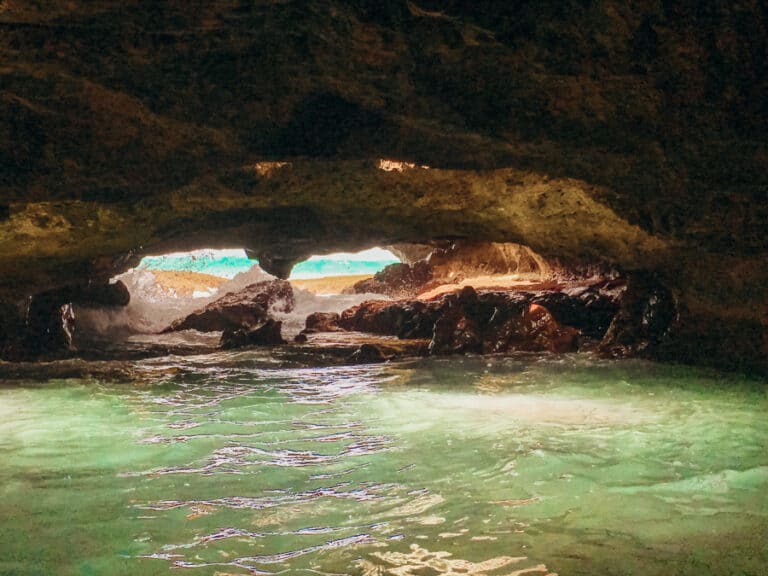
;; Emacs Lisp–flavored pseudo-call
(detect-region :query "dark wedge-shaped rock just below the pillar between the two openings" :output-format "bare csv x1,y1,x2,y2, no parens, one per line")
163,280,295,332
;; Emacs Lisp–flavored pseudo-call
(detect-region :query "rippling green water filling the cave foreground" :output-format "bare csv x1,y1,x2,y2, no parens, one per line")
0,352,768,576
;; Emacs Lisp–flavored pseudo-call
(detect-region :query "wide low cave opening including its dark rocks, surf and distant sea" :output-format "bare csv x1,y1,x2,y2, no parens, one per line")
33,240,656,363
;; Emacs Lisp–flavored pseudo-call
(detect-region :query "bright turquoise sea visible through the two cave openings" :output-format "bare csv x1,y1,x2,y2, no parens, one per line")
139,253,399,278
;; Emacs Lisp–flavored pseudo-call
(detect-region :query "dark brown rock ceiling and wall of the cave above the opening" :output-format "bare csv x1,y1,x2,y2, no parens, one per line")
0,0,768,365
